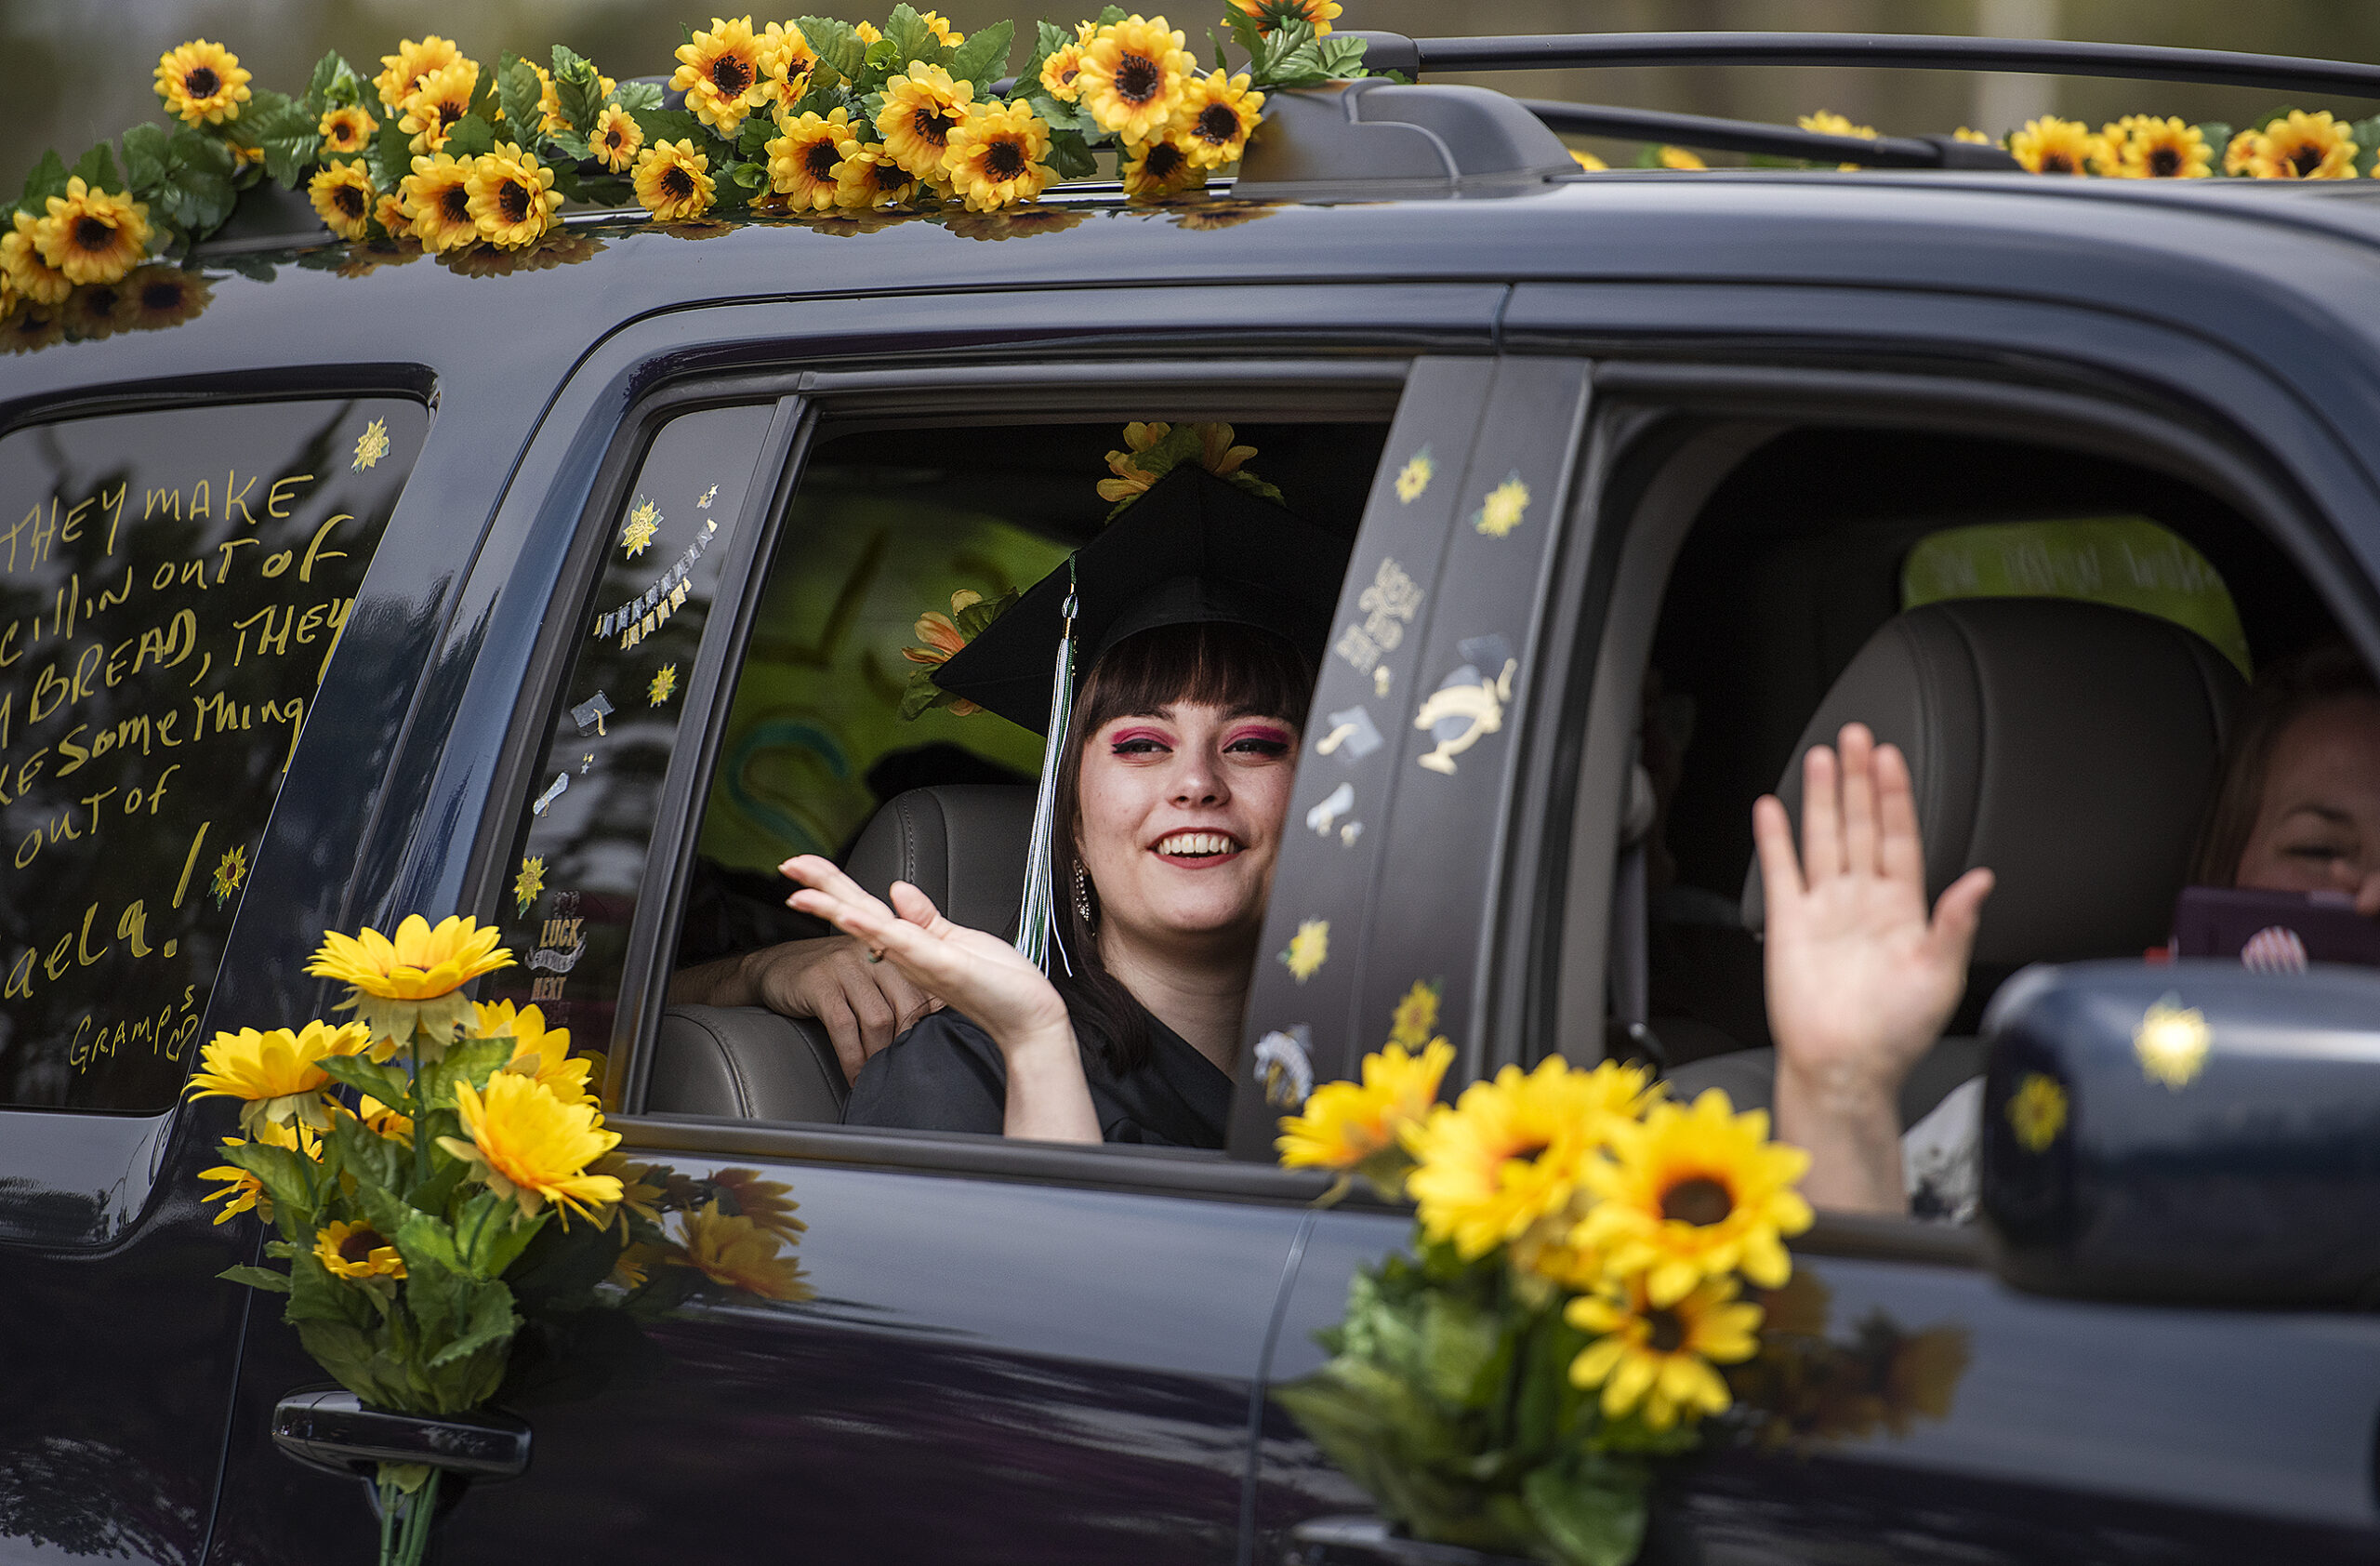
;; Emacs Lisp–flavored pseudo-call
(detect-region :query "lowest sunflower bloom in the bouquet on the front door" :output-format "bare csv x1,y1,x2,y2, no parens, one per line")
1561,1278,1761,1430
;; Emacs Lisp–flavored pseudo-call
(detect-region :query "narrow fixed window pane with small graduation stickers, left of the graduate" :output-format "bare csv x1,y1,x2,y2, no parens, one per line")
483,403,774,1075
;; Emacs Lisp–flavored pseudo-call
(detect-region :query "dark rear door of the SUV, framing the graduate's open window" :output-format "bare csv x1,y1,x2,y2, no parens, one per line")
205,290,1495,1561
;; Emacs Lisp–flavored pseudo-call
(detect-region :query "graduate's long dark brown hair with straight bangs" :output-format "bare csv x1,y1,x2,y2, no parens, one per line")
1050,621,1314,1073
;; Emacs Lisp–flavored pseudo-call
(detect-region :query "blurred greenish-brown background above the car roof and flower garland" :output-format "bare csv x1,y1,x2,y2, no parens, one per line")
0,0,2380,191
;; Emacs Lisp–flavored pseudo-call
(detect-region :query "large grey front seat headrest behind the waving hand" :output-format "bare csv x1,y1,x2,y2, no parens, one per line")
1742,597,2242,966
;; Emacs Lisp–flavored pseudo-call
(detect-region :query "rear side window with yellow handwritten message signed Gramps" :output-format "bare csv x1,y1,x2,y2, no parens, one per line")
0,397,429,1111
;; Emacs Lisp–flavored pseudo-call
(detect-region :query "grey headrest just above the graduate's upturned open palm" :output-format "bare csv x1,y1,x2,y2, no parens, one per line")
842,783,1033,936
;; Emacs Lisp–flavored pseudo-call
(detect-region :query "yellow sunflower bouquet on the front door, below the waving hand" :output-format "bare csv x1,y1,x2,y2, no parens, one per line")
1276,986,1818,1566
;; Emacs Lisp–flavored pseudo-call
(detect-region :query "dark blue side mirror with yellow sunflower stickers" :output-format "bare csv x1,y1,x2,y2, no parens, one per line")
1982,962,2380,1307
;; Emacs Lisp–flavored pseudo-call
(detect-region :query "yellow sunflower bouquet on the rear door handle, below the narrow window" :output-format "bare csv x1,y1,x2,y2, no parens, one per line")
188,914,809,1566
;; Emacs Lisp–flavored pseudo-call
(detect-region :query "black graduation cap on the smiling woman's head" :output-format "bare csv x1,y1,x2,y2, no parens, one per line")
933,461,1350,733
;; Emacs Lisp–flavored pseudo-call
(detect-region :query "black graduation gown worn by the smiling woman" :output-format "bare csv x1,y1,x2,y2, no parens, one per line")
842,1012,1231,1148
